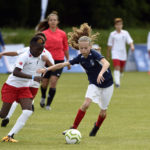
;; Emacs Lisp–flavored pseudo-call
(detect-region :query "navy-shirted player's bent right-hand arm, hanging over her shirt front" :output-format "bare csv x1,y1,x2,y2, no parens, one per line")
97,58,110,84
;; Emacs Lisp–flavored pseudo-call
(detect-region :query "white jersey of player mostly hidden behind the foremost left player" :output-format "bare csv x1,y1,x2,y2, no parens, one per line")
17,47,54,88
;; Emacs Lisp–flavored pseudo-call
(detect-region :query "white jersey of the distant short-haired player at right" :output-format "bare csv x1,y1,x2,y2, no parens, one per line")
107,30,133,61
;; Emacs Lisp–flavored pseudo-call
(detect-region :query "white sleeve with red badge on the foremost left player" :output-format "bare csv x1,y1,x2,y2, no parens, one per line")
15,54,28,69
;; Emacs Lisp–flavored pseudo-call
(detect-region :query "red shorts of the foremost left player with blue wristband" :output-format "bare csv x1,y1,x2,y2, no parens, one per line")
1,83,33,103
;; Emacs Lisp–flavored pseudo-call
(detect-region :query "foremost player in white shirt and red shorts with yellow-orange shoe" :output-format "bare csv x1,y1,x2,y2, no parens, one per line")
0,37,45,142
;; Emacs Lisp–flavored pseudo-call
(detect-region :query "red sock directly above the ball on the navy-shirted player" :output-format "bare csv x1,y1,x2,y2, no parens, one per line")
73,109,85,129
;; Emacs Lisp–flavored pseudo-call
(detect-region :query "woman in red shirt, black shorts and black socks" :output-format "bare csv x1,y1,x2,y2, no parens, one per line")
36,11,70,110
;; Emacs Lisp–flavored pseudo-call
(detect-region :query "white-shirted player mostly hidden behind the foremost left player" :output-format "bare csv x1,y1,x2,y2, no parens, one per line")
0,32,54,127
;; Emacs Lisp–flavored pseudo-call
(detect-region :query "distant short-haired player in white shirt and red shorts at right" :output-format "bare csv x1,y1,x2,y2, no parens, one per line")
107,18,134,87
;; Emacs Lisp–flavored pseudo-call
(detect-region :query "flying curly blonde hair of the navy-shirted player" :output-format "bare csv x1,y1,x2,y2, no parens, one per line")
68,23,99,50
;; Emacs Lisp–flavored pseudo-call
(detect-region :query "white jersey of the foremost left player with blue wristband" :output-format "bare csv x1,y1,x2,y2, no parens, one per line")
6,51,41,87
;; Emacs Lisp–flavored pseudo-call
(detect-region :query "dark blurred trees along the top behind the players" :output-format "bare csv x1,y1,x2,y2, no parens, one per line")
0,0,150,29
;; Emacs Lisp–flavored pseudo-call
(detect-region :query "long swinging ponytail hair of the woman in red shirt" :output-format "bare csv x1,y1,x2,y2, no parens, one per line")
35,11,58,32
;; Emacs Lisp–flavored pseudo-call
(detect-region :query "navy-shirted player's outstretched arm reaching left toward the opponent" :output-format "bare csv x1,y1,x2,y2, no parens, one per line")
37,62,70,73
